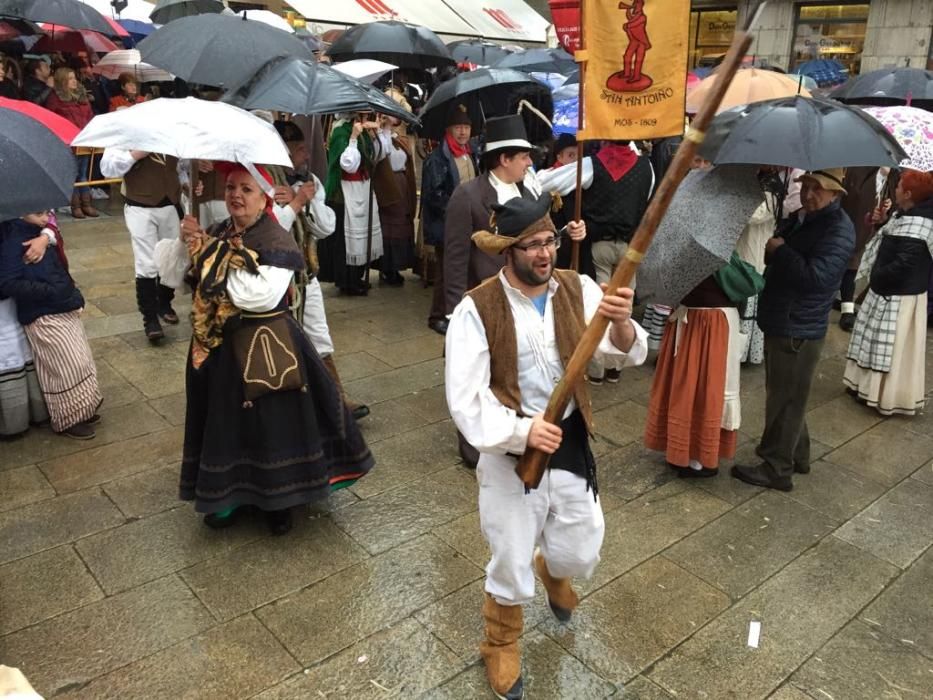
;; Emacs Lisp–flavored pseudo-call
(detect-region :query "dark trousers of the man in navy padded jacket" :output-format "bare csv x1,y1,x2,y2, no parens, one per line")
756,335,825,476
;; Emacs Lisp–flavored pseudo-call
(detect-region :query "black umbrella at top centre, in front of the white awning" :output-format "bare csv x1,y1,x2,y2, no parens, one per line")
327,21,456,69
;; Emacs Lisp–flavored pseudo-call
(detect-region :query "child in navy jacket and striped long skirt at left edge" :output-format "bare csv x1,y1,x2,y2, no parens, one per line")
0,212,102,440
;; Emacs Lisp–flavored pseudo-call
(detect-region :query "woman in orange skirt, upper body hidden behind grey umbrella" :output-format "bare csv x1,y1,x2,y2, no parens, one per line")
645,276,743,478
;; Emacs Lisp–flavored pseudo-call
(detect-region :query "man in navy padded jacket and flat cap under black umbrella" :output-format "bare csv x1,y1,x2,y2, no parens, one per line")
732,168,855,491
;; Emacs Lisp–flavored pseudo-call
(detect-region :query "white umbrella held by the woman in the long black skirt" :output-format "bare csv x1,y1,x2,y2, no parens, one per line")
72,97,292,167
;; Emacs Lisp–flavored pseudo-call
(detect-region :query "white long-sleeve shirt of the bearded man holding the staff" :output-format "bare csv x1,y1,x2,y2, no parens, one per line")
445,271,648,455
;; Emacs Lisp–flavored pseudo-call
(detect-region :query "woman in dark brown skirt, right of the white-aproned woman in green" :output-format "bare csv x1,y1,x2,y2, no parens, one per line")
374,89,418,287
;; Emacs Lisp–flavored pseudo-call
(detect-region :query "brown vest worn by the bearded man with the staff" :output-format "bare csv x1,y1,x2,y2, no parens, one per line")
467,270,593,435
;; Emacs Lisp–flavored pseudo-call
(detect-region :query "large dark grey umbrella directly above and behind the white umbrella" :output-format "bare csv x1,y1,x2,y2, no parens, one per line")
136,14,313,87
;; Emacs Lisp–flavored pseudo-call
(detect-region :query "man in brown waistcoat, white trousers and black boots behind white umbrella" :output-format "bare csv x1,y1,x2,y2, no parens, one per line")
100,148,181,342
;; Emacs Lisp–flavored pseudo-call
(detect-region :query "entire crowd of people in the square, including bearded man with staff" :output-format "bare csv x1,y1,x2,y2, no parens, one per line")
0,30,933,698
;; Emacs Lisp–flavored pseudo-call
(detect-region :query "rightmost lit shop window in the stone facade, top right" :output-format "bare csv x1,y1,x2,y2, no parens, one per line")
792,3,868,84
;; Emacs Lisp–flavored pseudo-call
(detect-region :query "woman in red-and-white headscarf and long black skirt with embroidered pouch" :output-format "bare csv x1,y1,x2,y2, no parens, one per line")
167,166,373,534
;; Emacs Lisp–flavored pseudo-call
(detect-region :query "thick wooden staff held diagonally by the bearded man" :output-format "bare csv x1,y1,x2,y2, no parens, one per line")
515,28,752,489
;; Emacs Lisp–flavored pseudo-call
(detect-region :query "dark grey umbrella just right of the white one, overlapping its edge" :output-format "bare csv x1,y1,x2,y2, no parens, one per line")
223,56,418,124
